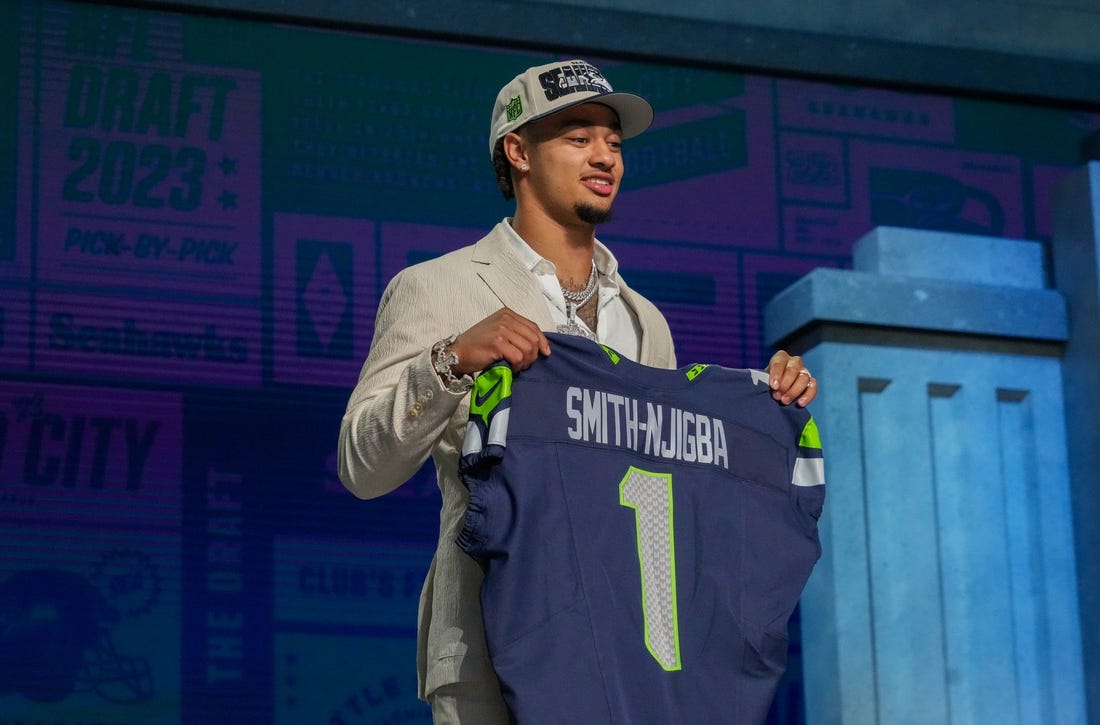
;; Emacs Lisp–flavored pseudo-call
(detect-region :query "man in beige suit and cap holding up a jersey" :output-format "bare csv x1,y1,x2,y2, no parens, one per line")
339,61,816,725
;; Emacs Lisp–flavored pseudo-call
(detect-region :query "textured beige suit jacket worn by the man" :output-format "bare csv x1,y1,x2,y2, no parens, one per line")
339,222,675,699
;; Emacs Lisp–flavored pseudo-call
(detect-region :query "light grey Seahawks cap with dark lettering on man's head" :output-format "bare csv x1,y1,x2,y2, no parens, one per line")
488,61,653,157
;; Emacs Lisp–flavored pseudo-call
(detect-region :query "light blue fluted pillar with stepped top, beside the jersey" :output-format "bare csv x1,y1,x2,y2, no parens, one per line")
765,228,1086,725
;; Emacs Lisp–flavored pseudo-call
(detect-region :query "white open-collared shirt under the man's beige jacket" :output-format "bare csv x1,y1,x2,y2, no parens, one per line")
504,218,641,361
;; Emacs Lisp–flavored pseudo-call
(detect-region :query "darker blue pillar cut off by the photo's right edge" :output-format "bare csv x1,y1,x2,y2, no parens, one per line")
1052,162,1100,723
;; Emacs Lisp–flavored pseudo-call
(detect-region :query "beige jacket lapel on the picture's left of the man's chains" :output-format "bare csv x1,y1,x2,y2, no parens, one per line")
472,221,554,330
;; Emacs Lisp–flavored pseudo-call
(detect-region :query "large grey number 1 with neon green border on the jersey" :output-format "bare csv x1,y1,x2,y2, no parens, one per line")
619,465,680,671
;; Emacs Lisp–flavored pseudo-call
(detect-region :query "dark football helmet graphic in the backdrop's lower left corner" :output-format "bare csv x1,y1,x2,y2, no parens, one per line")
0,569,153,703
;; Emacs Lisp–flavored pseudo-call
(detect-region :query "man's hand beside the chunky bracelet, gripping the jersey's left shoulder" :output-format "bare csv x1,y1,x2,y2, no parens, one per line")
451,307,550,375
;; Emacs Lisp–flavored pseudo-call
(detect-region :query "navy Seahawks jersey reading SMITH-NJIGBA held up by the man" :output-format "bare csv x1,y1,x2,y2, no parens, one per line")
459,333,825,725
